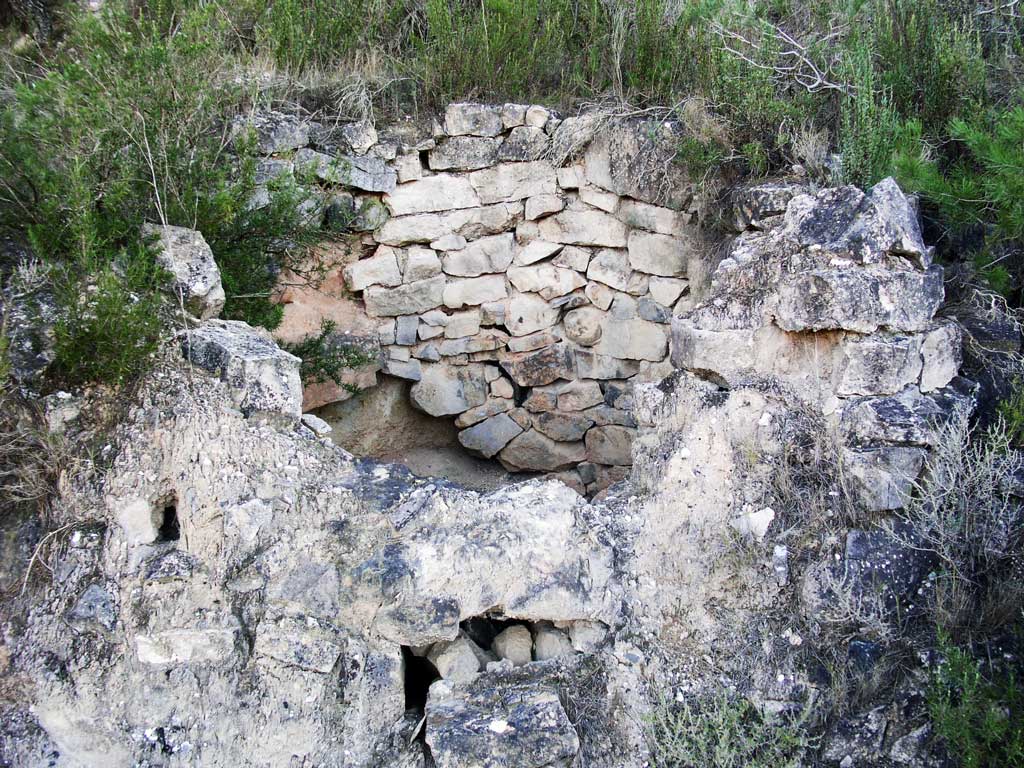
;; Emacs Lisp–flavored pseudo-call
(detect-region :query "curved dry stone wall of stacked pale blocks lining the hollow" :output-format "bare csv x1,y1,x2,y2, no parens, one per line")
243,103,700,493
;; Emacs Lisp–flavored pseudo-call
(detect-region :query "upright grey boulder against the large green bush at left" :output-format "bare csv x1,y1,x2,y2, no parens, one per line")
142,224,224,319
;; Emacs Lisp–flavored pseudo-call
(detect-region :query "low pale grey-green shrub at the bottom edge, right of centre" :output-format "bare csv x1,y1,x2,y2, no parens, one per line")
645,693,810,768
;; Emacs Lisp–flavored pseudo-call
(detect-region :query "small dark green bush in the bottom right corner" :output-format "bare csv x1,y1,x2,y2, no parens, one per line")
928,638,1024,768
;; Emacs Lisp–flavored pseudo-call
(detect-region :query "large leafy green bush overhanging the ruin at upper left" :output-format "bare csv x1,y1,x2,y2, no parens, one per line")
0,2,318,383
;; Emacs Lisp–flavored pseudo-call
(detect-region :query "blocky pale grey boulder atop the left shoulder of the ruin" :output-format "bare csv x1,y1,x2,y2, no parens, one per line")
181,319,302,420
